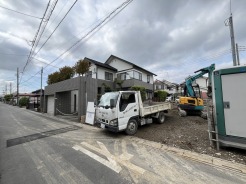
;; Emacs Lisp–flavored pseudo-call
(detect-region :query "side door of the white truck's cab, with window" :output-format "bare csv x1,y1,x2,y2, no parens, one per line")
118,92,139,130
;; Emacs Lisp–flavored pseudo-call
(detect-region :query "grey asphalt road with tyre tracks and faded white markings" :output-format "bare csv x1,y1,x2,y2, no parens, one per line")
0,103,246,184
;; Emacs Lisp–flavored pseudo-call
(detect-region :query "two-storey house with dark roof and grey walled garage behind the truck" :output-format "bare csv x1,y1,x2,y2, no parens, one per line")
45,55,155,118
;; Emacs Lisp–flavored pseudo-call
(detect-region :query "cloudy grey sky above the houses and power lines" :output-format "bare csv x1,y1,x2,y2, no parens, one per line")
0,0,246,95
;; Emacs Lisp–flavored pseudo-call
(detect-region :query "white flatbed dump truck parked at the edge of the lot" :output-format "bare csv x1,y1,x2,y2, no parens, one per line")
96,91,171,135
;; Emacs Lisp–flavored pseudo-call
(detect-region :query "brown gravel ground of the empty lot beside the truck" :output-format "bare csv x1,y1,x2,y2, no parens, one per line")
135,109,246,164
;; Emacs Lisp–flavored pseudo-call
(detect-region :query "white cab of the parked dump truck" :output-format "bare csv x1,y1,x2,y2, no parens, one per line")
96,91,139,132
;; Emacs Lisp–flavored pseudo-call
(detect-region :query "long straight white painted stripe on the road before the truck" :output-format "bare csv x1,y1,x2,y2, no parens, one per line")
73,145,122,173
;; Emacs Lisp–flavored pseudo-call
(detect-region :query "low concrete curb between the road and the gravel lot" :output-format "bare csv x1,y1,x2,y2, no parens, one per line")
129,137,246,174
